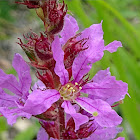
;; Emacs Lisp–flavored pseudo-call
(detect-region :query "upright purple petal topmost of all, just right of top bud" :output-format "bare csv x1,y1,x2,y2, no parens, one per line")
60,15,79,45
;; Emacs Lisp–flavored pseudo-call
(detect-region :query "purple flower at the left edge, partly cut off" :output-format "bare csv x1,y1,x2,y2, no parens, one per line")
0,54,31,125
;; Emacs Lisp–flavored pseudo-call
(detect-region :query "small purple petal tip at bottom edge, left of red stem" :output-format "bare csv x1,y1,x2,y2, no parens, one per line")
37,127,49,140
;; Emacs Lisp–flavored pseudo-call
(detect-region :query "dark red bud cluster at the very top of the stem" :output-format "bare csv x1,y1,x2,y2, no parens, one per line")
36,0,67,35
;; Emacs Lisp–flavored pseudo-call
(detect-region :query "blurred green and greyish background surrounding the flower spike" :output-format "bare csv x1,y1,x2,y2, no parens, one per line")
0,0,140,140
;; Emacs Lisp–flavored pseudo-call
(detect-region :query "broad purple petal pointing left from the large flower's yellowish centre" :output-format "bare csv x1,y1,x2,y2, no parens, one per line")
21,89,60,115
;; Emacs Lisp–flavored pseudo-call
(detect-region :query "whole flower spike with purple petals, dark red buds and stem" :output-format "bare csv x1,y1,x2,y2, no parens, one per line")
0,0,128,140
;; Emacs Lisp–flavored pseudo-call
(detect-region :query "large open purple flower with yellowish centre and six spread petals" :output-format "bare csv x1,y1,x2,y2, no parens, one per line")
24,24,127,129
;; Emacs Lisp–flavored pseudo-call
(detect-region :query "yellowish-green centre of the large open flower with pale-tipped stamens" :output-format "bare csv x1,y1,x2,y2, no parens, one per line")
59,83,82,101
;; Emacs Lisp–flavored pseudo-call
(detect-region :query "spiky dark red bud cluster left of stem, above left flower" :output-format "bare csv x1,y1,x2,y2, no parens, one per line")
18,32,55,70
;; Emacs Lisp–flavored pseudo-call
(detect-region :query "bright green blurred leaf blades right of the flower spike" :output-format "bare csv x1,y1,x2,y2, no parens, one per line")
66,0,140,139
